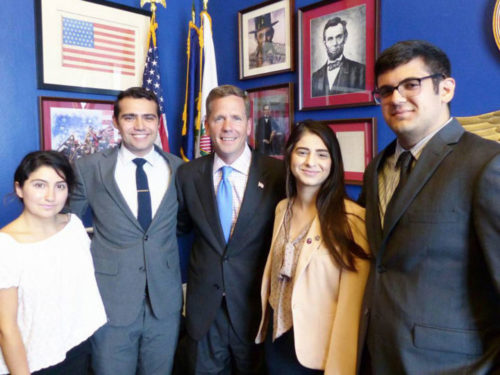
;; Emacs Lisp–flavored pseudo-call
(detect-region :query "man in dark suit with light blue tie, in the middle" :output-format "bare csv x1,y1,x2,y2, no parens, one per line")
177,85,285,375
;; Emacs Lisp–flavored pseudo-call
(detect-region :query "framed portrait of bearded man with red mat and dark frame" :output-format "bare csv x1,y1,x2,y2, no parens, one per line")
298,0,379,110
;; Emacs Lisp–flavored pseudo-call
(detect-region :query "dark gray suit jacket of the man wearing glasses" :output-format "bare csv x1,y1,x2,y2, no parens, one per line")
360,120,500,374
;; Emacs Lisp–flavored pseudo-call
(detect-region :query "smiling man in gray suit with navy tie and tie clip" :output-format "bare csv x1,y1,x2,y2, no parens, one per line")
70,87,182,375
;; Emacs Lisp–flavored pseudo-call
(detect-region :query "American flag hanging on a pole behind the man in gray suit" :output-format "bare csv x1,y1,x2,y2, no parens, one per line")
142,35,170,151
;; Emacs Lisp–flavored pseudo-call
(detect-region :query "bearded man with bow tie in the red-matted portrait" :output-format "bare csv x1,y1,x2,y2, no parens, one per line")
311,17,365,97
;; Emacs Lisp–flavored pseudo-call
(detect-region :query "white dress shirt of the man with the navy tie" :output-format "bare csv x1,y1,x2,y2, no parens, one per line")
115,145,171,217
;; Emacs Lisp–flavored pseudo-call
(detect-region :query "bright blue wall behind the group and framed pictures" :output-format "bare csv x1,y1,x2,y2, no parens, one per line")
0,0,500,227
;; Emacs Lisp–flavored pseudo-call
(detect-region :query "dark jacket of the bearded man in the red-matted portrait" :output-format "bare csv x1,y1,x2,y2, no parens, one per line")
311,57,366,97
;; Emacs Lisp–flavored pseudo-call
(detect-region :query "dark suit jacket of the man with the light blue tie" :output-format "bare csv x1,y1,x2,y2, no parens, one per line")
177,151,285,343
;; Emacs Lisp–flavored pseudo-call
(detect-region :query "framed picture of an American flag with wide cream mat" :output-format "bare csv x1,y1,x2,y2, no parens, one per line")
35,0,151,95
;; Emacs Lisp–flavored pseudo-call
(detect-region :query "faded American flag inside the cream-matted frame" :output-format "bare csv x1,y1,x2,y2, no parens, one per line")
62,17,136,76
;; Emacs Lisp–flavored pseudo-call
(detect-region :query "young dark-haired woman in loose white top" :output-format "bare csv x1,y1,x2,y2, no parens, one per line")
0,151,106,375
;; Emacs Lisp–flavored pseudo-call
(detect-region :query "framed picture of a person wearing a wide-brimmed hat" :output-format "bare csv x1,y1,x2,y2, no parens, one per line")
238,0,295,79
